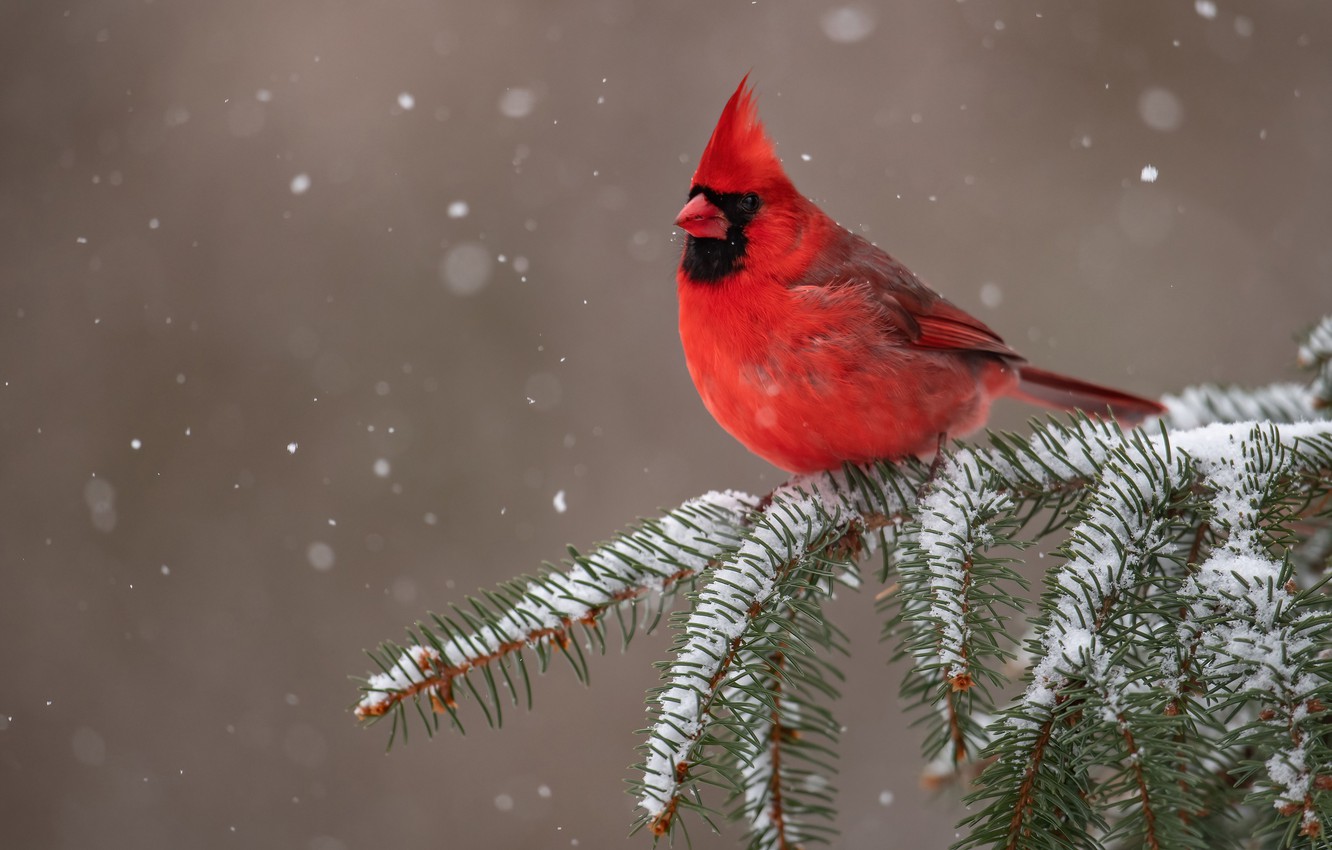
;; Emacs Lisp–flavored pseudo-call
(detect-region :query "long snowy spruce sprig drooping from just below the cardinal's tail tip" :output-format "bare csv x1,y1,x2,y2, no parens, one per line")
978,433,1192,847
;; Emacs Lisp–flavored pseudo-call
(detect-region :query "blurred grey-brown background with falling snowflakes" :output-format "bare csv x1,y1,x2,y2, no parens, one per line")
0,0,1332,850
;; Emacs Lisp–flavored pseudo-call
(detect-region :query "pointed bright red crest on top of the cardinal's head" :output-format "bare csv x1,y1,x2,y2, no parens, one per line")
694,75,785,192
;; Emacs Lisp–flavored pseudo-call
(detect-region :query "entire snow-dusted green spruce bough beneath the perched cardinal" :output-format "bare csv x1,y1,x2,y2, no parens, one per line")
354,317,1332,850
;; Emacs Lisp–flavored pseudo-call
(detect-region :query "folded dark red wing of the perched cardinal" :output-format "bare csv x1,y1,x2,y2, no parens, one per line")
797,228,1024,360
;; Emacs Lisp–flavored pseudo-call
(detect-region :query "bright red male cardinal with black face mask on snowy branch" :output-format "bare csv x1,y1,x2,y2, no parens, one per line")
675,76,1164,473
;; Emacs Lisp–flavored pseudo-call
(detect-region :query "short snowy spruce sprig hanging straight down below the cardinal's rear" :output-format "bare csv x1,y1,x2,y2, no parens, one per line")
884,416,1161,767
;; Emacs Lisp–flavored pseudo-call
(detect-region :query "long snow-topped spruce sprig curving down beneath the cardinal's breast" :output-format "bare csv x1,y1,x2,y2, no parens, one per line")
635,465,920,846
